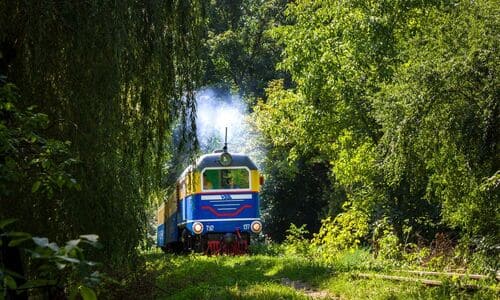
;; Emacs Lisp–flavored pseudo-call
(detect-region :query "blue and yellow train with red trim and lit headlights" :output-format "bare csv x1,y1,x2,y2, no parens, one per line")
157,144,263,254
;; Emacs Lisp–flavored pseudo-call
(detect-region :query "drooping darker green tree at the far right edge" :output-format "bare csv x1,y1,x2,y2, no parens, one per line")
376,1,500,239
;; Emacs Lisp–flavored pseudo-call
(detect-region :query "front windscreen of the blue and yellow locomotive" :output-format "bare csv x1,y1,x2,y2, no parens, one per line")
203,168,250,190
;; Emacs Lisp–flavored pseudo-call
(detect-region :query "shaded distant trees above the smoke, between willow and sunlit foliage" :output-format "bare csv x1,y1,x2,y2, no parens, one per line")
202,0,286,102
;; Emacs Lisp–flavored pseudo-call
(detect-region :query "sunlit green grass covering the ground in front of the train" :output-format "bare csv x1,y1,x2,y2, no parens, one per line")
145,250,498,299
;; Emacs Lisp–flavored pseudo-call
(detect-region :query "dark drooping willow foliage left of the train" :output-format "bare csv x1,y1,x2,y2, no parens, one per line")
0,0,203,266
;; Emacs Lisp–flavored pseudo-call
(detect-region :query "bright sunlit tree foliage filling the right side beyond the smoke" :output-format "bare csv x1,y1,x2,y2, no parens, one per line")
254,0,500,250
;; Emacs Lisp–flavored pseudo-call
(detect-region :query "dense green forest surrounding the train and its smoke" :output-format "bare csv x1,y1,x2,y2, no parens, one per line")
0,0,500,298
